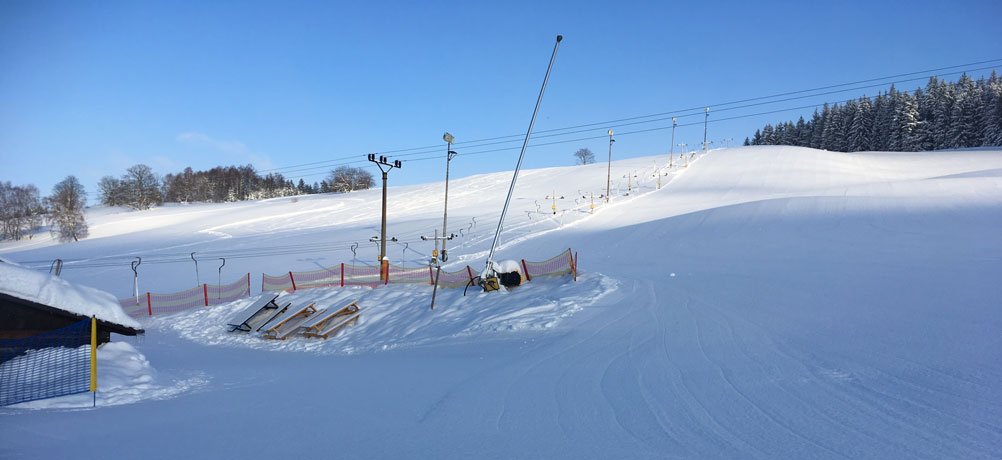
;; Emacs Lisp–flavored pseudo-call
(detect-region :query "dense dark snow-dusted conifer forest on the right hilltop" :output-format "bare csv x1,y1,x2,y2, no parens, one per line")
744,71,1002,151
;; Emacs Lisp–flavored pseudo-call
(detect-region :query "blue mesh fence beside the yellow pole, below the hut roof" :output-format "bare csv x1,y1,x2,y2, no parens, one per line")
0,320,90,406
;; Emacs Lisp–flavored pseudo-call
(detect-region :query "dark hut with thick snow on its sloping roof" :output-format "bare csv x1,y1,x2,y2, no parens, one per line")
0,260,143,356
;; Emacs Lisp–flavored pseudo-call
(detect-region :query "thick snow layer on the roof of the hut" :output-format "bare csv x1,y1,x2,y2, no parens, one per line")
0,263,142,329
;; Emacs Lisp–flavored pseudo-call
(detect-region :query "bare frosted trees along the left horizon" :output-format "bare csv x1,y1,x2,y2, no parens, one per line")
0,164,375,242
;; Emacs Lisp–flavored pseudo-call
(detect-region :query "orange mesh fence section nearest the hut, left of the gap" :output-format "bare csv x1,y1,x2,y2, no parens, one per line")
118,274,251,318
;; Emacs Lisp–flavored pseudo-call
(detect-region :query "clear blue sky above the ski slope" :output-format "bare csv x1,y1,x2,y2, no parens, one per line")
0,1,1002,198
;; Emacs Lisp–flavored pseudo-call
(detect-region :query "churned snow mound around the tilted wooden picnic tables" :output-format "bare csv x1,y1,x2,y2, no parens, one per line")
165,274,615,354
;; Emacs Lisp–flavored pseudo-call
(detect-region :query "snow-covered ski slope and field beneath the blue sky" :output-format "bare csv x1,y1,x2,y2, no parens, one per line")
0,147,1002,459
